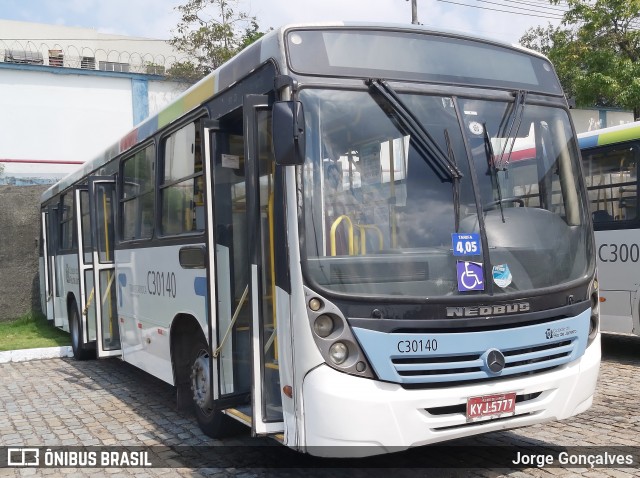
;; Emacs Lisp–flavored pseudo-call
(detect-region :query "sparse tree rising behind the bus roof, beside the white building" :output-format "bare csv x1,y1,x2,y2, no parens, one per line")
167,0,264,81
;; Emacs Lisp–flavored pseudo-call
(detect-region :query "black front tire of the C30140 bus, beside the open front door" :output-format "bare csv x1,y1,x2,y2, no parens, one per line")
187,337,247,438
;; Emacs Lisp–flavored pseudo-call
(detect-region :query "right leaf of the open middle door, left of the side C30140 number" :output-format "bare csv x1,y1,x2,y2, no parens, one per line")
85,176,122,357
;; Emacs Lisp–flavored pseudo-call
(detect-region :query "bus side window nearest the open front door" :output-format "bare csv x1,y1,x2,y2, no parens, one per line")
160,121,204,235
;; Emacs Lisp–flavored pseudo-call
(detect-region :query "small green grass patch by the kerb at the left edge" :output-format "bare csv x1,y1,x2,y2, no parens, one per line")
0,312,71,352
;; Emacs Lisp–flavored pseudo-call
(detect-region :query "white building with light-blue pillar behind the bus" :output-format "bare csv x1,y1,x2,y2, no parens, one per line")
0,20,190,184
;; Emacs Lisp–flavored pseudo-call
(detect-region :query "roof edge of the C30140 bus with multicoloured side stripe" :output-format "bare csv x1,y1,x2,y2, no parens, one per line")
41,22,545,202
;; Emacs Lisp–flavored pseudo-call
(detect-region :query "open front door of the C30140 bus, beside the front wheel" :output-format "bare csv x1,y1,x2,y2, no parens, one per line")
204,95,284,435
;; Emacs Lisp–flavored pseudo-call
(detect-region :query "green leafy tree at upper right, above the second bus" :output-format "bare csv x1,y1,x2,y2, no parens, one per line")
520,0,640,117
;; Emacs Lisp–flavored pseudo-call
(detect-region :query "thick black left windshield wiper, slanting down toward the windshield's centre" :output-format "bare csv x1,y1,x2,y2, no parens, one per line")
365,79,462,182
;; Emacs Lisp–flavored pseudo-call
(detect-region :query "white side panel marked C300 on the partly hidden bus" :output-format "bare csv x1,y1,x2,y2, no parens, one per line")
595,229,640,334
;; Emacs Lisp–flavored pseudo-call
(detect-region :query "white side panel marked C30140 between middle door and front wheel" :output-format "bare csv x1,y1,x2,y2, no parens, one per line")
115,246,208,385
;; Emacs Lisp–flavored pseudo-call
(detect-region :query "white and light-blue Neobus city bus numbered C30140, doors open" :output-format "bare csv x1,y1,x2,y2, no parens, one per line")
41,23,600,455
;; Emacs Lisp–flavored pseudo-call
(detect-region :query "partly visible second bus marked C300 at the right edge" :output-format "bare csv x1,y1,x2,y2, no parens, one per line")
578,122,640,335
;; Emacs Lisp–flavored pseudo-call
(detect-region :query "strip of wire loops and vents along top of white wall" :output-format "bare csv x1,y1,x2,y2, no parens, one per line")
0,40,187,75
